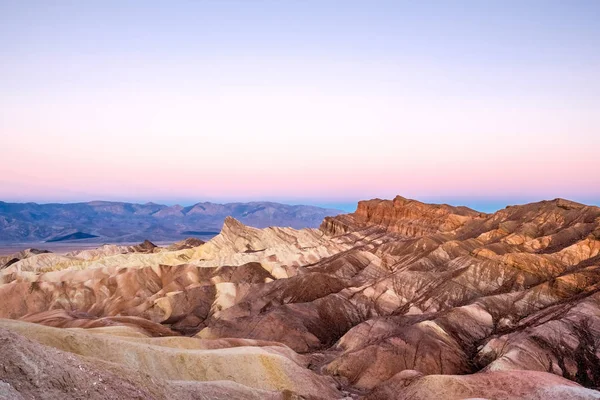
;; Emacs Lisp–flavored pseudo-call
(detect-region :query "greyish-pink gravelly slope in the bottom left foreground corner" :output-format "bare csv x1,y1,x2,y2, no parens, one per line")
0,327,293,400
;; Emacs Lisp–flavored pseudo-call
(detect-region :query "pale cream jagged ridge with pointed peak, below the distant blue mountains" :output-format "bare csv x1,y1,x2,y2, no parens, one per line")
0,217,349,283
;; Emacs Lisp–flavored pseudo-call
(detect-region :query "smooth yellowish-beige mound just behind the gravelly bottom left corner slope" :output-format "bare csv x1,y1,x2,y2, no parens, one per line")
0,320,337,398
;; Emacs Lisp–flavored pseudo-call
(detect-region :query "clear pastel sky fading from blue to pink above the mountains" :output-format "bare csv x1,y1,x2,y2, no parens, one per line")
0,0,600,211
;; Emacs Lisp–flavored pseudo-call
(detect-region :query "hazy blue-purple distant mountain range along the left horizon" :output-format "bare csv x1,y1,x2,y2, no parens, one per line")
0,201,342,243
